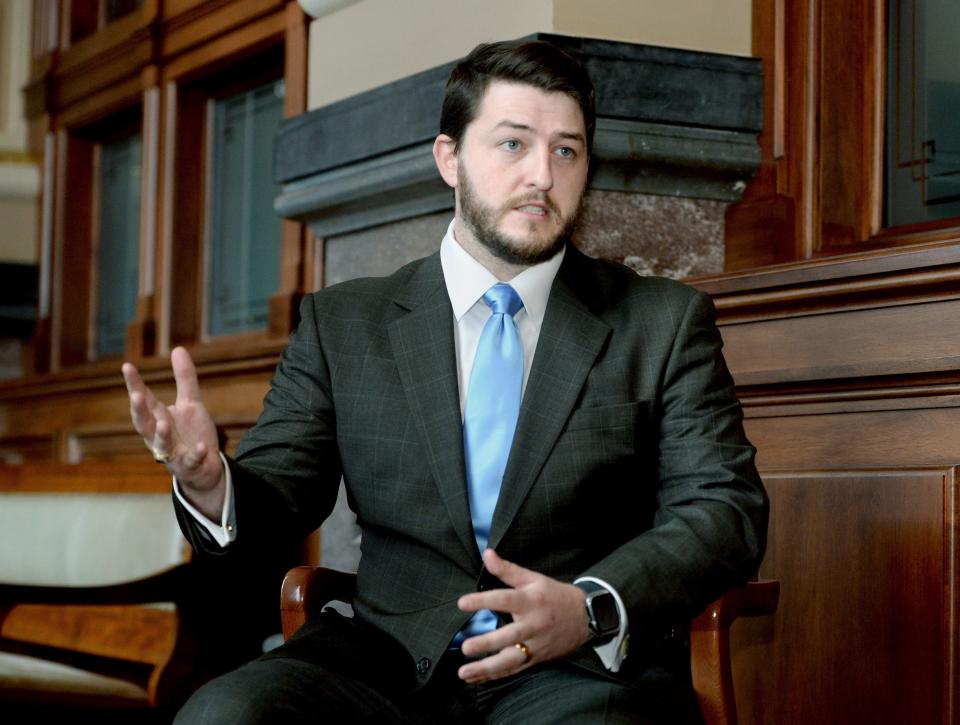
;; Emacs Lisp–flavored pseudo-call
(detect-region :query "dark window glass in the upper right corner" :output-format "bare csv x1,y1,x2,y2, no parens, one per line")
885,0,960,226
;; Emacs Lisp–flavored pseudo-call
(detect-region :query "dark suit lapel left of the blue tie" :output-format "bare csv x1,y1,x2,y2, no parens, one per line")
388,254,480,567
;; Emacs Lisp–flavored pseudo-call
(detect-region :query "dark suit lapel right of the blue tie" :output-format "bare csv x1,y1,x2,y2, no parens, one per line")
490,247,610,547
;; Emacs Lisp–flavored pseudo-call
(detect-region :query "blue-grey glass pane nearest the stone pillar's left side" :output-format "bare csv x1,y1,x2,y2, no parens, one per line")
205,81,283,335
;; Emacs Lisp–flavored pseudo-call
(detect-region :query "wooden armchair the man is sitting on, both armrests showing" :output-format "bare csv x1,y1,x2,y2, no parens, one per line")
280,566,780,725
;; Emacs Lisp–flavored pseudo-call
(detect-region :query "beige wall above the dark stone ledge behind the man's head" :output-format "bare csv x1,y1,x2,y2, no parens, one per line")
302,0,751,108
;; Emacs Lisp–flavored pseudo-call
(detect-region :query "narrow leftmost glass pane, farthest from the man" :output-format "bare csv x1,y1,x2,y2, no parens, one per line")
95,135,140,357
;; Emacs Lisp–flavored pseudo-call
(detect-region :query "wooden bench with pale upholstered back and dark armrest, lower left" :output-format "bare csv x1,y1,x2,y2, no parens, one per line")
0,462,193,708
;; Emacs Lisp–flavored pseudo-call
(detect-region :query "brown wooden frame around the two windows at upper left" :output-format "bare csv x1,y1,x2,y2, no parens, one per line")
26,0,308,378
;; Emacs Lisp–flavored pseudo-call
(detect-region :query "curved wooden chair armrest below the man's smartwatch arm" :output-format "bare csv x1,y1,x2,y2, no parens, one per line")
690,580,780,725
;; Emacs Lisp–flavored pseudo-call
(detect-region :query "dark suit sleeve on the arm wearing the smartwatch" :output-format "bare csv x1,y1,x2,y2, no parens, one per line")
587,292,768,633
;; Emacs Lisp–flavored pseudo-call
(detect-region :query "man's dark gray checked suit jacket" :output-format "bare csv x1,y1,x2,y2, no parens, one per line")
181,247,767,684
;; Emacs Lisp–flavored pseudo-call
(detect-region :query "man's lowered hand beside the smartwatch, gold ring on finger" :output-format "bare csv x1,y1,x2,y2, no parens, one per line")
457,549,590,682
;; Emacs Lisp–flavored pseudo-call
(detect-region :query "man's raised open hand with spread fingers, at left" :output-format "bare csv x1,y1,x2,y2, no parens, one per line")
122,347,225,521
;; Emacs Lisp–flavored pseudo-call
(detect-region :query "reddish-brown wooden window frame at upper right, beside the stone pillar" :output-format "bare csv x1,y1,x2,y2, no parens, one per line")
726,0,960,270
